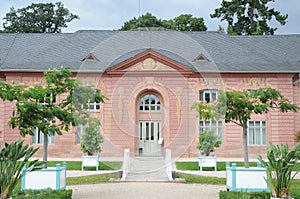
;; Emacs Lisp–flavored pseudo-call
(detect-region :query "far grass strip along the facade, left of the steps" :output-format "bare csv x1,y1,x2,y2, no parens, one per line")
48,161,122,170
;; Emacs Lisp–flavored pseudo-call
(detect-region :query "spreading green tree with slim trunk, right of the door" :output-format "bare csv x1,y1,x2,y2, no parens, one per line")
191,88,299,168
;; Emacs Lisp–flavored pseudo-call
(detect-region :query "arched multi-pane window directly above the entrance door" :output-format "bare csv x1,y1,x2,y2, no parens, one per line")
140,94,160,111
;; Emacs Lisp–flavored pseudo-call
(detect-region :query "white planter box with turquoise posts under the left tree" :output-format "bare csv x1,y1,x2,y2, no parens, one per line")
21,163,67,190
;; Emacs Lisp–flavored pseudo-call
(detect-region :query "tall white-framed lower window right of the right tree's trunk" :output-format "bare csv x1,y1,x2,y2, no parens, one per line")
248,121,267,145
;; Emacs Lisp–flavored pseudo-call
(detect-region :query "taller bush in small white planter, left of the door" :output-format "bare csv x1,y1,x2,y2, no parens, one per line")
80,118,103,170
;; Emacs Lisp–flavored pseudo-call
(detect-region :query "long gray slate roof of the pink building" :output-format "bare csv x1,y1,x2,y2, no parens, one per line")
0,30,300,73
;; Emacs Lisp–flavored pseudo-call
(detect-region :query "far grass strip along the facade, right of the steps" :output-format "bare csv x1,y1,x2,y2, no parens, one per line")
176,162,300,171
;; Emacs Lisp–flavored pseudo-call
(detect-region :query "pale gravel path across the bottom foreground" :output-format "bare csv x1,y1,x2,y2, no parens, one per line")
67,182,226,199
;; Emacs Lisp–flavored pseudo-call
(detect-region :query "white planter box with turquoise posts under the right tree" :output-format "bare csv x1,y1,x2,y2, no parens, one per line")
226,162,270,192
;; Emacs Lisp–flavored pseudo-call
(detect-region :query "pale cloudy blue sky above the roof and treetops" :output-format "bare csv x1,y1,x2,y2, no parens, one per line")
0,0,300,34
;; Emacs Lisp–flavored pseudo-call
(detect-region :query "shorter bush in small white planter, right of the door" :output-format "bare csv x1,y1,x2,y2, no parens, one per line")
197,131,222,171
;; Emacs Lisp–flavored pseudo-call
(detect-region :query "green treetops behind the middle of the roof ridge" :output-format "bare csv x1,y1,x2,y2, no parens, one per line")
120,13,207,31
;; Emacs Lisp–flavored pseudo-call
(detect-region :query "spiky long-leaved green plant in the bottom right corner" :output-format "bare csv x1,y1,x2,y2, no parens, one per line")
258,142,300,199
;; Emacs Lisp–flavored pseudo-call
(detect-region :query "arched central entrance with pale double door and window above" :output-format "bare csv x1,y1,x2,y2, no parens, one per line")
137,91,164,156
